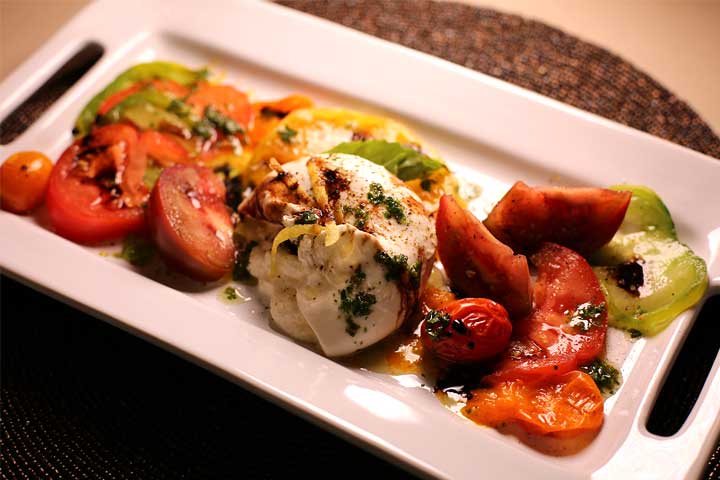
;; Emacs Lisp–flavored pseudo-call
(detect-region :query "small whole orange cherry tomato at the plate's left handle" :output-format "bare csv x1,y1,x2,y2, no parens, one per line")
0,152,52,213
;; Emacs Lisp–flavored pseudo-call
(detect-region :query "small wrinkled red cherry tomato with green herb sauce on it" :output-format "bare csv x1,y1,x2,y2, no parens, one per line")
422,298,512,363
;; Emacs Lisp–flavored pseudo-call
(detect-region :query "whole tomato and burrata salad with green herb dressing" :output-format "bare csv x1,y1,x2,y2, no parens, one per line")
0,62,707,452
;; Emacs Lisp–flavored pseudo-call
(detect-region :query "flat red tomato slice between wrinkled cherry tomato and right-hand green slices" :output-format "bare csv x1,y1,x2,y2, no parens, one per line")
485,243,607,384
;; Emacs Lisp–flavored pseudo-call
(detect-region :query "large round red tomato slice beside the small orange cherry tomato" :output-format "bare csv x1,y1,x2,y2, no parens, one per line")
45,125,148,243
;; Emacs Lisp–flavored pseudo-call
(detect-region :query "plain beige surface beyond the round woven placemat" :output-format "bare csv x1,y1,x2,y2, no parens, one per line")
0,0,720,132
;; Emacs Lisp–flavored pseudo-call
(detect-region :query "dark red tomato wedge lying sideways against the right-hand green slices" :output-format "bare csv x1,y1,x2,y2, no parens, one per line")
485,182,632,254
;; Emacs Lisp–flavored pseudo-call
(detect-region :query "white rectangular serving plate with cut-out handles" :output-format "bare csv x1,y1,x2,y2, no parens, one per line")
0,1,720,479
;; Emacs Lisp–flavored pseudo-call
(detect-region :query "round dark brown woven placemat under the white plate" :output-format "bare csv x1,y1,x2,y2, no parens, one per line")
0,0,720,479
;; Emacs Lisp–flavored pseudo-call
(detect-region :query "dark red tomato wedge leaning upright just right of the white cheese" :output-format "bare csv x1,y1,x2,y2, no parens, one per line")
436,195,532,318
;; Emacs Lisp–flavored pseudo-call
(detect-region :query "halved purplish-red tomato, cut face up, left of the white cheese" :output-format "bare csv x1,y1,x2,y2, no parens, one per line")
148,165,235,281
